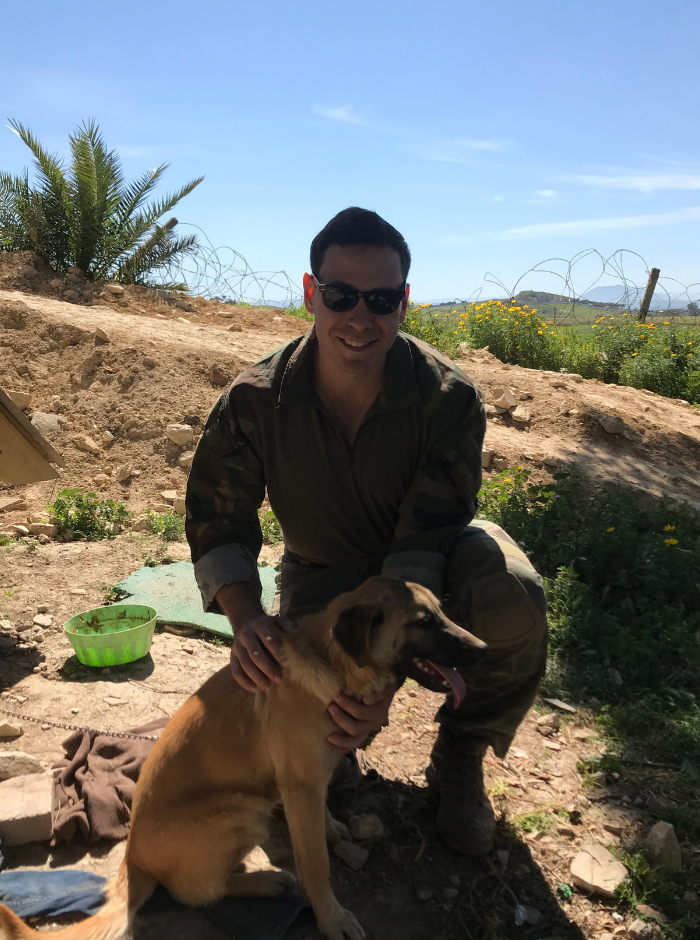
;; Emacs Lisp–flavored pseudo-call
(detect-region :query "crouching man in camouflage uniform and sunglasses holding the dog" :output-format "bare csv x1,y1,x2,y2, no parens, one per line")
186,208,546,854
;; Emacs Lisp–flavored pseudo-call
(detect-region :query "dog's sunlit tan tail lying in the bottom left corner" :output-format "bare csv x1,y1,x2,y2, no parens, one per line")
0,860,157,940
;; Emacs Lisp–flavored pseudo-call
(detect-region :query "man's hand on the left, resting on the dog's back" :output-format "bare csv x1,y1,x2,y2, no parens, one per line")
231,614,296,692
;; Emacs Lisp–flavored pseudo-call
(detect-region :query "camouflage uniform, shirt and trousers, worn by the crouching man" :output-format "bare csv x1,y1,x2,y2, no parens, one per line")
186,329,546,755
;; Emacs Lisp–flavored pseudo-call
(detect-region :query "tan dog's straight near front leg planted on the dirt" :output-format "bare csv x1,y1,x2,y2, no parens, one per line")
280,781,365,940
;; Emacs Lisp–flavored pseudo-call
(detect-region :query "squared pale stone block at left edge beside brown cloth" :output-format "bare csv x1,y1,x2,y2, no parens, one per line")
0,771,54,845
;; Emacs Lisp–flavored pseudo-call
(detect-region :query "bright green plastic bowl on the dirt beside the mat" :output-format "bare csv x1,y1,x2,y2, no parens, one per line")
63,604,156,666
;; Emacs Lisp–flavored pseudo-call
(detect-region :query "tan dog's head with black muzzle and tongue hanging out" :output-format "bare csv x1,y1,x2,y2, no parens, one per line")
333,577,487,705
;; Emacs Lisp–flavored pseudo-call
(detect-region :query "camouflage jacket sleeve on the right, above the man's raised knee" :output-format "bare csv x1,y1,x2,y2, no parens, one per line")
382,385,486,597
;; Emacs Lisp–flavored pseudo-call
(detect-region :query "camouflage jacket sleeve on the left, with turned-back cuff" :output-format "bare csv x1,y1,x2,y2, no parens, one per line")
185,390,265,613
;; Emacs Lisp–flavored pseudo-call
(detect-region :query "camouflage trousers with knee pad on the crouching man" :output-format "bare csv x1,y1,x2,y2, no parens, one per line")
273,519,547,757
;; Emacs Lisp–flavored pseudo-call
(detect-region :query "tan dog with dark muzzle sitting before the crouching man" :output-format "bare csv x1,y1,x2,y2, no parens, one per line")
0,578,486,940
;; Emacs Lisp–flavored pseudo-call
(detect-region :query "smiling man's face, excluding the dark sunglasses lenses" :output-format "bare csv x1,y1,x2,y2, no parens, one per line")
304,245,408,371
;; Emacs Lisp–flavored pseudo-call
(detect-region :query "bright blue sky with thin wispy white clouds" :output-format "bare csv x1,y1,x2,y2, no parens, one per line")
0,0,700,300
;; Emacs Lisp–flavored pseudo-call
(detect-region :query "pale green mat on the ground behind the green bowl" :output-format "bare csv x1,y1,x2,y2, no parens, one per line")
115,561,275,637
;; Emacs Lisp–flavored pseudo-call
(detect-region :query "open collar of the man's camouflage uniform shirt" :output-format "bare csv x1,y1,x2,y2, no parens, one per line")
277,327,421,416
